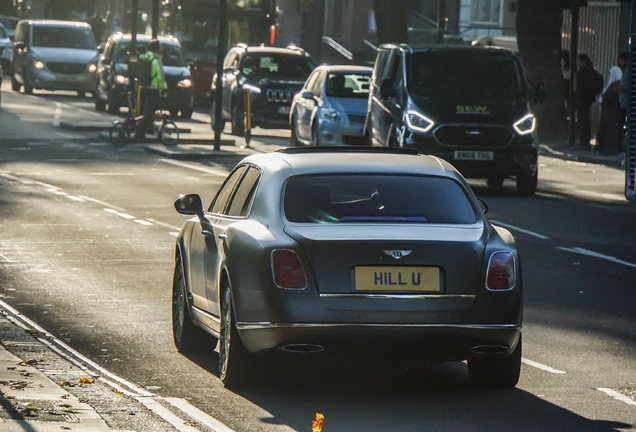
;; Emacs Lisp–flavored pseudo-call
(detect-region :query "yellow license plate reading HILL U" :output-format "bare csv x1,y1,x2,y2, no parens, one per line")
355,267,441,292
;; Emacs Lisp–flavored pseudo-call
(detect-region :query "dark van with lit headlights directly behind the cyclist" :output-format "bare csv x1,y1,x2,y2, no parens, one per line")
95,33,194,118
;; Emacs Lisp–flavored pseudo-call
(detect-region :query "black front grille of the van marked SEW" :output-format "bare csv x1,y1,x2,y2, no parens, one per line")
433,125,514,147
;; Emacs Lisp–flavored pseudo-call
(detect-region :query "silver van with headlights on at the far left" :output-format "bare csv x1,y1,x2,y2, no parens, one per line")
11,20,98,96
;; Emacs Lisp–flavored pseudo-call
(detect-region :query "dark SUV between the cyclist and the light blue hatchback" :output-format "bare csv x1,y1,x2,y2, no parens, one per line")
211,44,314,135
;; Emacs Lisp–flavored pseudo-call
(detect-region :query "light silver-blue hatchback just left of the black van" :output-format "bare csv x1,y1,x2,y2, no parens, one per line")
289,66,373,146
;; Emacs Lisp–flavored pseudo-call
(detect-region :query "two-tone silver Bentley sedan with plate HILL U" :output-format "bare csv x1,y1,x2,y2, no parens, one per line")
172,146,522,388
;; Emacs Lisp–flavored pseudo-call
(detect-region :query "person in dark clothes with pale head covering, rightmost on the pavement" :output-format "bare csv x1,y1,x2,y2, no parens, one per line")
595,66,624,155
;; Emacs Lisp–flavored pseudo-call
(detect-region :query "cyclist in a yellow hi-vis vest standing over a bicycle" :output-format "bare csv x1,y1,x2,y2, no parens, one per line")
135,39,168,141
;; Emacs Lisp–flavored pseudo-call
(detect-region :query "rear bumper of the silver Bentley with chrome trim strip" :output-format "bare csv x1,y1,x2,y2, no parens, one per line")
237,322,521,361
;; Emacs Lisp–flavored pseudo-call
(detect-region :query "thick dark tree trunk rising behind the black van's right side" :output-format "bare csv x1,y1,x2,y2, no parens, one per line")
516,0,567,141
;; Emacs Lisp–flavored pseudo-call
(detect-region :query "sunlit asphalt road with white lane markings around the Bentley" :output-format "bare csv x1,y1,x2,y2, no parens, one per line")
0,83,636,432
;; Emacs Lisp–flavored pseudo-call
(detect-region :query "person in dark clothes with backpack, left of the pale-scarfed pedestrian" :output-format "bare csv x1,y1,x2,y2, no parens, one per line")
576,54,604,149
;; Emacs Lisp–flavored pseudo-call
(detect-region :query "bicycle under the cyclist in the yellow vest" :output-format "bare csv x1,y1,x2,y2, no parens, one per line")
109,86,179,148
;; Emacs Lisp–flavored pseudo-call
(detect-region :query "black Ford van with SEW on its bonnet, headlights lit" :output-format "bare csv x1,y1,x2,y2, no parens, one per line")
366,45,545,195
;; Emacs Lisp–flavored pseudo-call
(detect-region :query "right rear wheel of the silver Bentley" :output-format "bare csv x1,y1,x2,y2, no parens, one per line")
468,336,521,389
